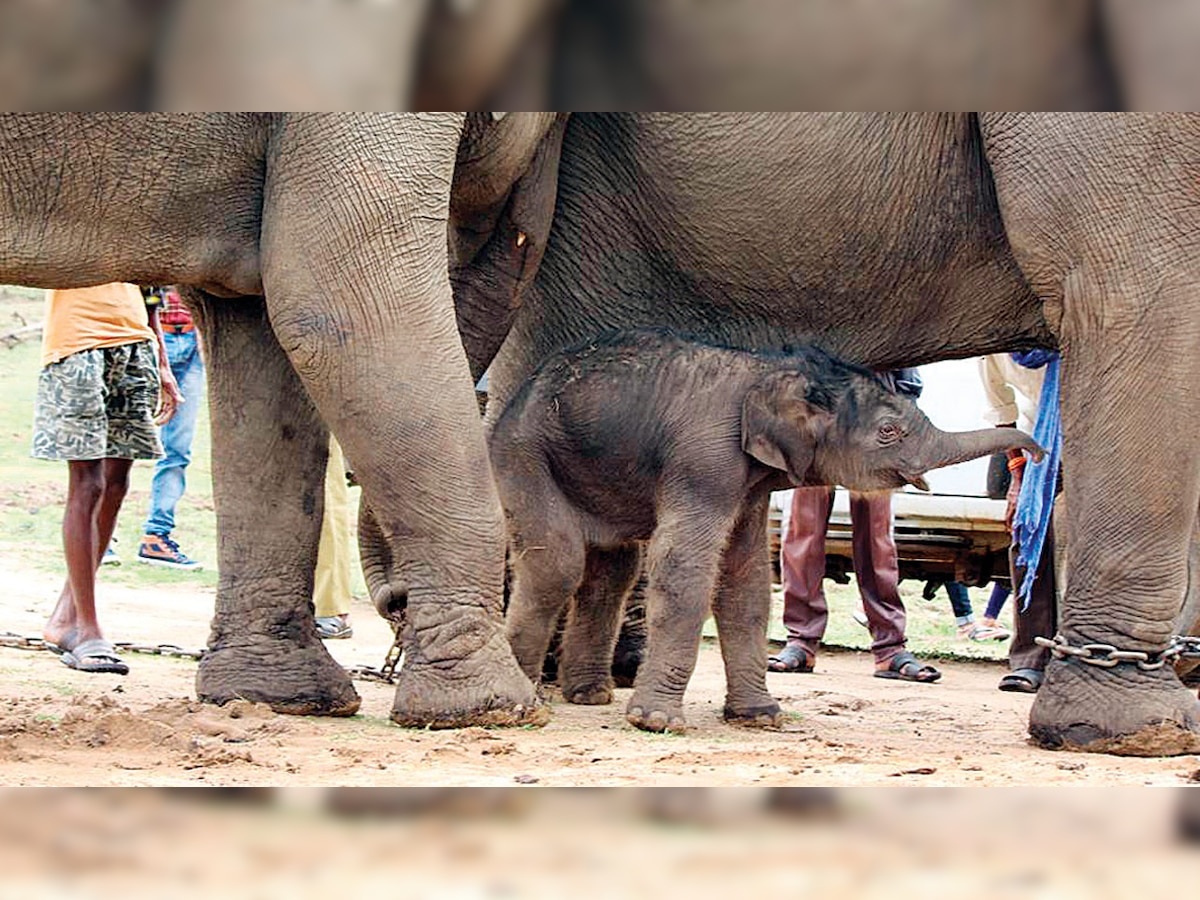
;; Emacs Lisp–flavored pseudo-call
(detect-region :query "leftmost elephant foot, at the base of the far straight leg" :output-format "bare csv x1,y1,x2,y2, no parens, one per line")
196,641,362,715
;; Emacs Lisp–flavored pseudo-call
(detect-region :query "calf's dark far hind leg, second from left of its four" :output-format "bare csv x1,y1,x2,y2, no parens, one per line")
558,546,641,704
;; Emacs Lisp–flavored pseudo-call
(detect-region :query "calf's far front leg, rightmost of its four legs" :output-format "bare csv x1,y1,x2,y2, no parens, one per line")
713,493,781,726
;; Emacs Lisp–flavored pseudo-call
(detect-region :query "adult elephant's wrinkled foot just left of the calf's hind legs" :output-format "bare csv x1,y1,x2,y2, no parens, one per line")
391,654,550,728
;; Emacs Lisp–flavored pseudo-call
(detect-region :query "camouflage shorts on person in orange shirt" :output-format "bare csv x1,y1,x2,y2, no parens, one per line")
32,341,162,460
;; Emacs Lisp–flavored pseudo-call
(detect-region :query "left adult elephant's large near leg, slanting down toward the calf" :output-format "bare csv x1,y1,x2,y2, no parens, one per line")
262,114,547,727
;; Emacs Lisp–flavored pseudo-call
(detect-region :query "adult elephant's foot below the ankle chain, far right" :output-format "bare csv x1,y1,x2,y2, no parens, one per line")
1030,660,1200,756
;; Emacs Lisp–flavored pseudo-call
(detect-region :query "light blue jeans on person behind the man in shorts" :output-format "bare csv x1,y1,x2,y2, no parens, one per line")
142,330,204,534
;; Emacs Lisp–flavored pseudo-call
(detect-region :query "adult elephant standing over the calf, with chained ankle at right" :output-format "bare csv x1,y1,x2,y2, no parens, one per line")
490,114,1200,754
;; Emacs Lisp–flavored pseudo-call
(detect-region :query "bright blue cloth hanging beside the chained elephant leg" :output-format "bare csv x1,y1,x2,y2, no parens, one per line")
1013,350,1062,611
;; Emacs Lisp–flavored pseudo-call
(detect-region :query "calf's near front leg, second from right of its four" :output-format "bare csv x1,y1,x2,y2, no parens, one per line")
625,510,734,732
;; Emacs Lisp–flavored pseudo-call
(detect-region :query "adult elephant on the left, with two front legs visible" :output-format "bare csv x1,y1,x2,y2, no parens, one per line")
0,114,562,725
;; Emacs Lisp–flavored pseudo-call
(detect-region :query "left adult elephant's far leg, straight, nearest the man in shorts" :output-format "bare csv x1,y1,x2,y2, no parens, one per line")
188,295,360,715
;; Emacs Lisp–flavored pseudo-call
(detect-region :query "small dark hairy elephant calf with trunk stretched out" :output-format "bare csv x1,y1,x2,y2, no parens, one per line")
490,330,1040,731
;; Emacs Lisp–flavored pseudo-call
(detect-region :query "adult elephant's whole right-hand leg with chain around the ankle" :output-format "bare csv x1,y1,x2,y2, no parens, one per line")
979,116,1200,756
